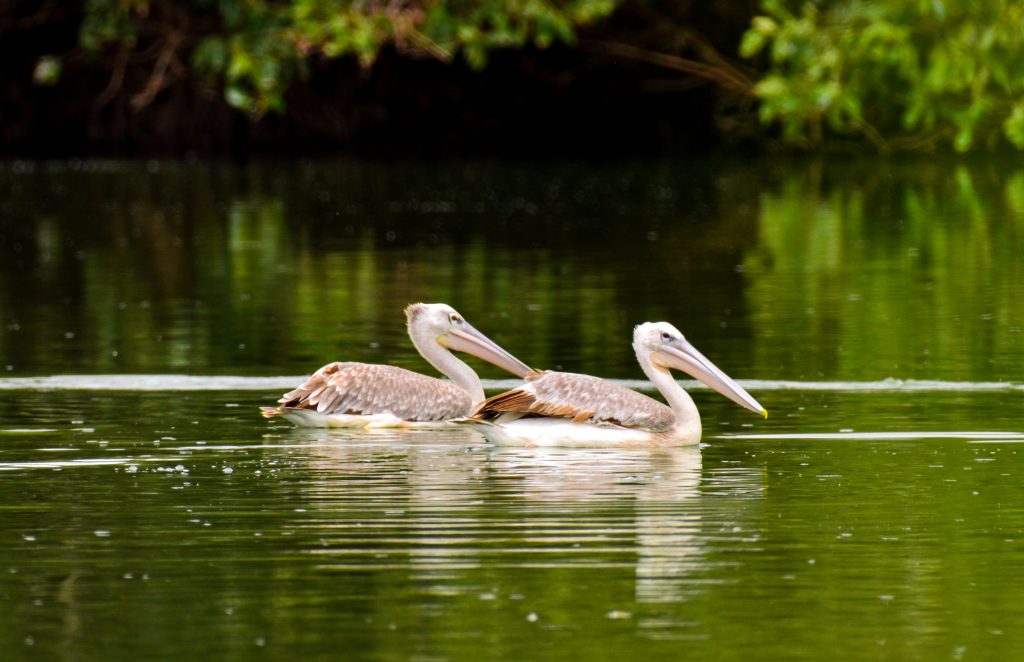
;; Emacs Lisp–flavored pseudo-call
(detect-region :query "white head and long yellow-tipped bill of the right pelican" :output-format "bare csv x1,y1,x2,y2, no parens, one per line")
633,322,768,418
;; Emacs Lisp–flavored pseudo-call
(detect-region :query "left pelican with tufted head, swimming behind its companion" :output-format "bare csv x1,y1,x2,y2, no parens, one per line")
260,303,531,427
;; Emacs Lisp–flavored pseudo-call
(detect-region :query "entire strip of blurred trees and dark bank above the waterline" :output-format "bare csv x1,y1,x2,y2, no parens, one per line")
6,0,1024,154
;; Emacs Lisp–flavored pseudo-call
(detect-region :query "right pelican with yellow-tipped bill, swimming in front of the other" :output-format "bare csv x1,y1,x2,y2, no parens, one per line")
454,322,768,446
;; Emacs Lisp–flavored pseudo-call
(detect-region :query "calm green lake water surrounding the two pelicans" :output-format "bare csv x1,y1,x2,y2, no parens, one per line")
0,159,1024,660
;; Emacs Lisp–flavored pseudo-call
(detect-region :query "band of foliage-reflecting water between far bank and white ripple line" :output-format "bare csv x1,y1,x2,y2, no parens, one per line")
0,161,1024,380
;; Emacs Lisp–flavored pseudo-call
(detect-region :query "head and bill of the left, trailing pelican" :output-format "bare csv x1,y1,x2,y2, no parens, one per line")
406,303,531,377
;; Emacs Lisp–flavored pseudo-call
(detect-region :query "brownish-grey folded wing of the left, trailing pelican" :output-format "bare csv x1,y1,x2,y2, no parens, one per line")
278,362,472,421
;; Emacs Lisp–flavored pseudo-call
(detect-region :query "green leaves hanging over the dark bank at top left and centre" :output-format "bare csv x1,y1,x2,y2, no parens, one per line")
80,0,621,114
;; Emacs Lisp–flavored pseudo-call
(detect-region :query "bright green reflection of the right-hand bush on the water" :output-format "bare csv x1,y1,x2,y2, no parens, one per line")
748,157,1024,380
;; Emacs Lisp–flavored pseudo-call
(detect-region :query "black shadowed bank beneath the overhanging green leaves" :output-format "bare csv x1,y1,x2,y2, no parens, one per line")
0,2,753,157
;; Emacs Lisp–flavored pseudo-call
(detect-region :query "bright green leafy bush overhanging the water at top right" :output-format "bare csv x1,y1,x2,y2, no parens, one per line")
740,0,1024,152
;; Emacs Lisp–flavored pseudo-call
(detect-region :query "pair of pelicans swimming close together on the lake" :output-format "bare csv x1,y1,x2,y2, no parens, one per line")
262,303,768,446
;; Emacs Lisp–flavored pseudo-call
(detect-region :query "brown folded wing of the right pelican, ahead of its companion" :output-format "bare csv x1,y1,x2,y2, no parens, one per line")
472,372,676,431
